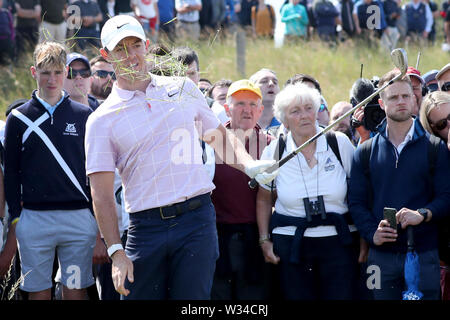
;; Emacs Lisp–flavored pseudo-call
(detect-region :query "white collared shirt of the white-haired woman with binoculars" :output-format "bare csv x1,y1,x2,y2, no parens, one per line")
260,126,356,237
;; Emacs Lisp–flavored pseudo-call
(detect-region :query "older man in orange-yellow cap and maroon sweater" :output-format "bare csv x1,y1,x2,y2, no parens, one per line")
211,80,273,300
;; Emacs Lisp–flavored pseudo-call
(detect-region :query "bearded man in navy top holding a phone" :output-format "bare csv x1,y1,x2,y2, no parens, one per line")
348,70,450,300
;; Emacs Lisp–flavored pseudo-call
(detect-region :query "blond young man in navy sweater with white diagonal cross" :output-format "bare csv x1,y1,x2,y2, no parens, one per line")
5,42,98,300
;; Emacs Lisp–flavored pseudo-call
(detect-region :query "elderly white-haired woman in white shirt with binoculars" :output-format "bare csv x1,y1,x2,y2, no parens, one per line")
257,84,358,300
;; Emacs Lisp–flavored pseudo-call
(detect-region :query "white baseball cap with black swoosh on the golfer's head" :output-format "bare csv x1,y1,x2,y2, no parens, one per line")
100,15,146,51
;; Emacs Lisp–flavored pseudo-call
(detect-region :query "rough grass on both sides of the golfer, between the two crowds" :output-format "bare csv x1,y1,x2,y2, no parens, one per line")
0,35,450,119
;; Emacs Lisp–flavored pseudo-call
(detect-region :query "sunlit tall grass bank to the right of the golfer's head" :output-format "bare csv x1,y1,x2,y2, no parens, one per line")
198,36,450,107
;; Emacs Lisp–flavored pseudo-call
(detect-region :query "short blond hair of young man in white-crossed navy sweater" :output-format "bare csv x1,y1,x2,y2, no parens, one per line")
33,42,67,69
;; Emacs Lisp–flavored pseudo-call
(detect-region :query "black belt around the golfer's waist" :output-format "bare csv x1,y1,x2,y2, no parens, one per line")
130,193,211,220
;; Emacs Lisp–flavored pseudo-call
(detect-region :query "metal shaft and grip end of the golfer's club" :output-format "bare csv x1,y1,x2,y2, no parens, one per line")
248,73,404,189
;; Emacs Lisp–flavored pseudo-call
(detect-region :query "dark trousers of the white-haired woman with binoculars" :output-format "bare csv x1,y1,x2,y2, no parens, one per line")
273,234,358,300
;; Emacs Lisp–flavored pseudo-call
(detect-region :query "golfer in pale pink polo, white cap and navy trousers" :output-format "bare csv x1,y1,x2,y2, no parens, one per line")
82,15,276,299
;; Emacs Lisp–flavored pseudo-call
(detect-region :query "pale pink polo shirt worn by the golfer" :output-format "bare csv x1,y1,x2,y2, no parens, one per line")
85,74,220,213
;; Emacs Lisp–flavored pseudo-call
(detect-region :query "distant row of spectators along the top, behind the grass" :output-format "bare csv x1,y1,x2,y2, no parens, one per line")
0,0,450,63
